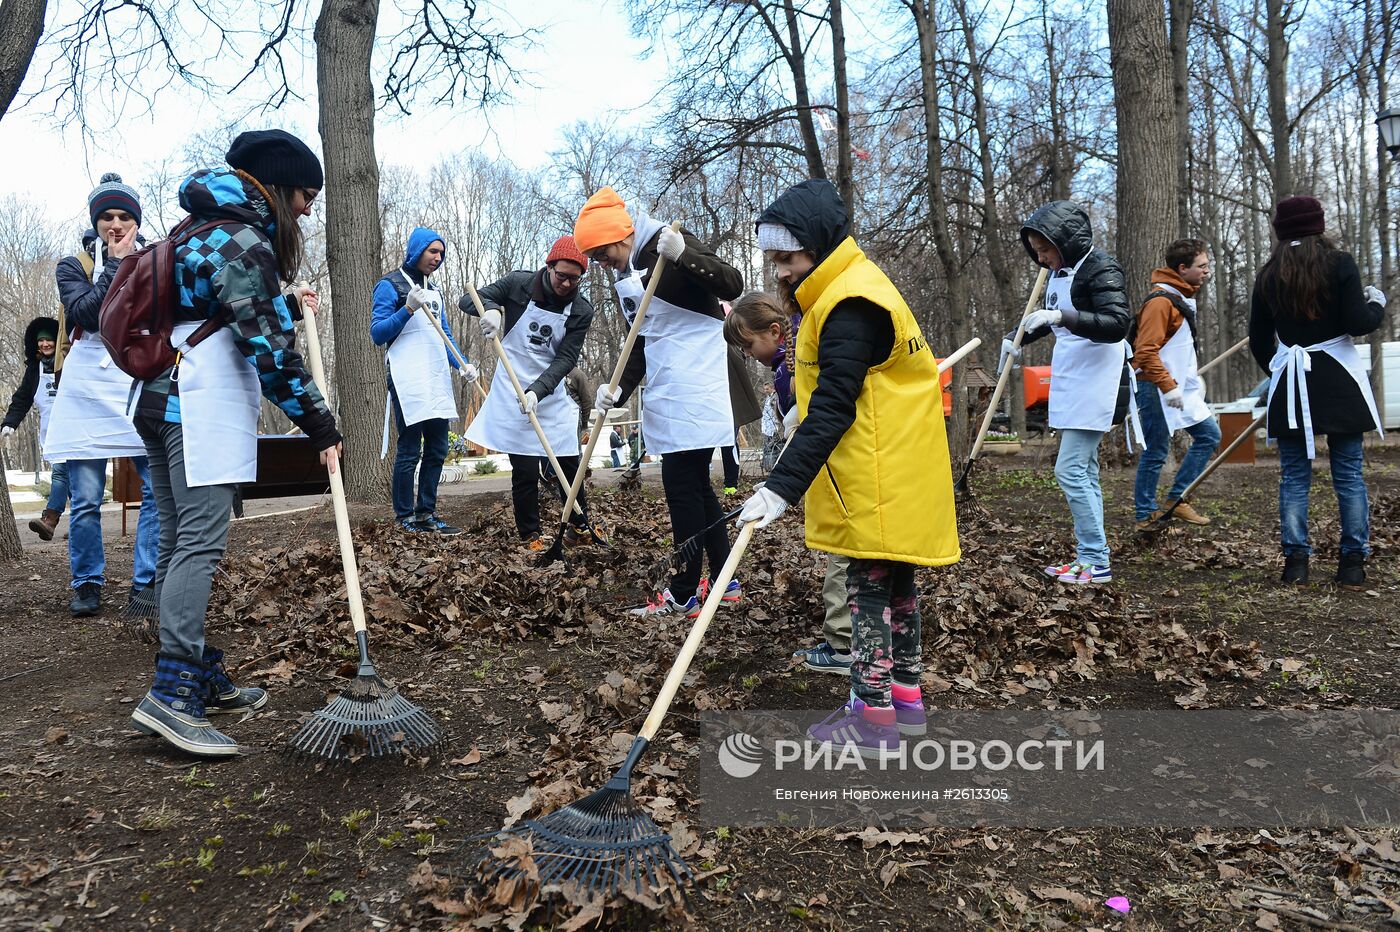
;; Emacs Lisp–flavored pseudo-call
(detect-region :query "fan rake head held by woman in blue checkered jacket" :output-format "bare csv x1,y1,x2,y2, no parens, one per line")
287,633,447,761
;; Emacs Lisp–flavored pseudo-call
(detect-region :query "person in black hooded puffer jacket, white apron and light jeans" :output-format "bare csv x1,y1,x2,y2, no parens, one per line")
1001,200,1141,585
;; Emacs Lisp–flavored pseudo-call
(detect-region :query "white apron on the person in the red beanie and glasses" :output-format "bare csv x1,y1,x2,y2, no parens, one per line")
466,301,582,456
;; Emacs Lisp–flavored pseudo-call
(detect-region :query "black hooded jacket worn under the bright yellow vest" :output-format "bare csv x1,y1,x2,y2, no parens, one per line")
757,179,895,502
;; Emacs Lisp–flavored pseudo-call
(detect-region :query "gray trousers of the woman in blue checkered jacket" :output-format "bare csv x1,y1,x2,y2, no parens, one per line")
136,417,238,663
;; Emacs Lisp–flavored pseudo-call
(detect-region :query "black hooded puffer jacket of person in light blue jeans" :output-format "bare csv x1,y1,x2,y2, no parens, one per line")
1021,200,1133,344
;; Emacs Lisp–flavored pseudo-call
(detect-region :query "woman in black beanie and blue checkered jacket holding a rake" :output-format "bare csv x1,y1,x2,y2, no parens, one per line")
132,130,340,757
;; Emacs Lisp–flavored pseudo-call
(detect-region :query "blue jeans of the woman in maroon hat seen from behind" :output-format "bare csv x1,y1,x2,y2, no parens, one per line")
1278,434,1371,557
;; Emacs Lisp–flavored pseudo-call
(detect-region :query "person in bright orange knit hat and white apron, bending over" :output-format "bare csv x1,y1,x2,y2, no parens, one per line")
574,188,745,617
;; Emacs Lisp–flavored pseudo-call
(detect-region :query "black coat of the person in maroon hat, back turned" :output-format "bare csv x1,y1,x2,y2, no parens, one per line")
1249,249,1385,439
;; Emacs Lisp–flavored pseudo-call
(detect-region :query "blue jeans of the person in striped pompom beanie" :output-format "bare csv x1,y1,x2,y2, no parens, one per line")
67,456,161,589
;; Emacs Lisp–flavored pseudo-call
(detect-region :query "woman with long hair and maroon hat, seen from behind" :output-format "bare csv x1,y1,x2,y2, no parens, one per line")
1249,196,1386,589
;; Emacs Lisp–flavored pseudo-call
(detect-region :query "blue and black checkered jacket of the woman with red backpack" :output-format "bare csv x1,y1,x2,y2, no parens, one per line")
137,168,340,449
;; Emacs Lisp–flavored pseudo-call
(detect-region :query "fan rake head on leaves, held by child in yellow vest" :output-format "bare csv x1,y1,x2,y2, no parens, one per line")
476,737,694,898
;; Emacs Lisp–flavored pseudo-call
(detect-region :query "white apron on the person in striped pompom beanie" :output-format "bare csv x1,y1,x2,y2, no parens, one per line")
43,333,146,463
